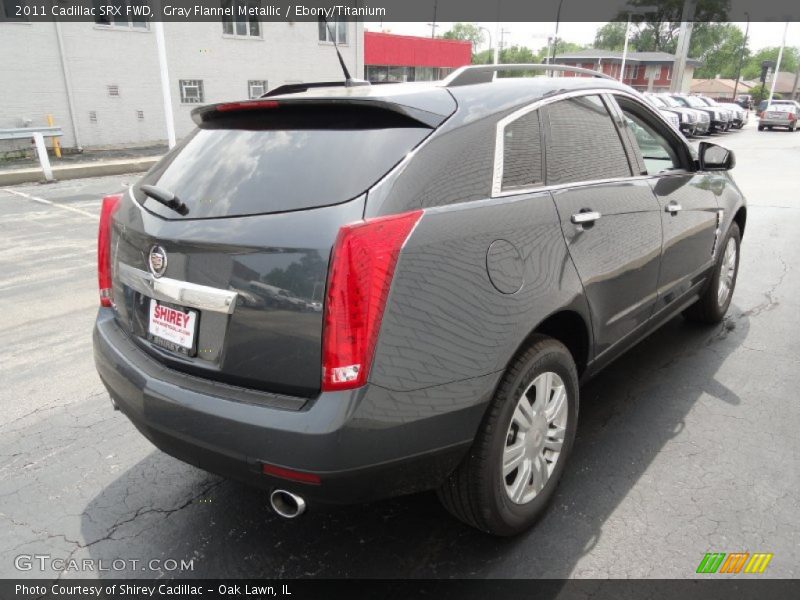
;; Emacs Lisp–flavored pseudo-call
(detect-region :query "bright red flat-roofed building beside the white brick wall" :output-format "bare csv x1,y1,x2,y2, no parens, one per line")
364,31,472,82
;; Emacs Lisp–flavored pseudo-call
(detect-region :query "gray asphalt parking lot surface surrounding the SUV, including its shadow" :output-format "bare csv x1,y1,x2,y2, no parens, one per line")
0,120,800,578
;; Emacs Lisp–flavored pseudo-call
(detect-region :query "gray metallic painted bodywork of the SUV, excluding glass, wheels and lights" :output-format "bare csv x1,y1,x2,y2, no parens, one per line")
94,78,744,502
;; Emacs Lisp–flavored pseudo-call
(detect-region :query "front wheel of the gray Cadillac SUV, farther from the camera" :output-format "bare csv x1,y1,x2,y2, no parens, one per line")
683,223,742,324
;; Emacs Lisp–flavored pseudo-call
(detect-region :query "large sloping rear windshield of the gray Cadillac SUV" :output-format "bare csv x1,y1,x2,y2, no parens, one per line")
134,109,431,219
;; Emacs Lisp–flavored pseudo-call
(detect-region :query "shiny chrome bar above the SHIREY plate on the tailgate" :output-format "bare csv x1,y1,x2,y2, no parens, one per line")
117,263,238,315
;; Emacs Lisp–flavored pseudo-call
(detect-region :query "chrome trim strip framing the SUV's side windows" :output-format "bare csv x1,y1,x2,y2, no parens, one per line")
492,88,691,198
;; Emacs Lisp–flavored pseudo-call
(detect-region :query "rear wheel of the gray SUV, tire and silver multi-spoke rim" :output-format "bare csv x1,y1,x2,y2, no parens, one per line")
438,335,579,536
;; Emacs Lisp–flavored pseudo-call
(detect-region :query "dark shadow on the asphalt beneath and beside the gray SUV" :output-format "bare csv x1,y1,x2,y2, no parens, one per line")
81,307,749,578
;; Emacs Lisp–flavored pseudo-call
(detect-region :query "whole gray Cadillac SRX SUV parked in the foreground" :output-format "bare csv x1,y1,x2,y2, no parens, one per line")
94,65,746,535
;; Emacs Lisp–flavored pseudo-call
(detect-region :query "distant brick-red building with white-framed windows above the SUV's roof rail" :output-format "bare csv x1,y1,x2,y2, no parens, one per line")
555,49,702,93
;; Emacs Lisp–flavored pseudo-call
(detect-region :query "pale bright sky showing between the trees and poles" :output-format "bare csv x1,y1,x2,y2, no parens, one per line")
374,22,800,50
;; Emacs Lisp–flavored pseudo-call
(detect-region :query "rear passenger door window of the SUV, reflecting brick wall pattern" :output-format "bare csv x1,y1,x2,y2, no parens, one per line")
545,95,631,185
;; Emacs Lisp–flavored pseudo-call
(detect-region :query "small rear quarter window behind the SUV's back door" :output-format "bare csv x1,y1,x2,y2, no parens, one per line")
500,111,543,192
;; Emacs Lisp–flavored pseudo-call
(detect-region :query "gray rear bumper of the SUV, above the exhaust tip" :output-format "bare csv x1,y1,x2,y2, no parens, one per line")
94,309,499,504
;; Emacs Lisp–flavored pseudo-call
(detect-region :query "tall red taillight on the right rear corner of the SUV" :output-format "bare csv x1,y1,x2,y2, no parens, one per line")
322,210,423,391
